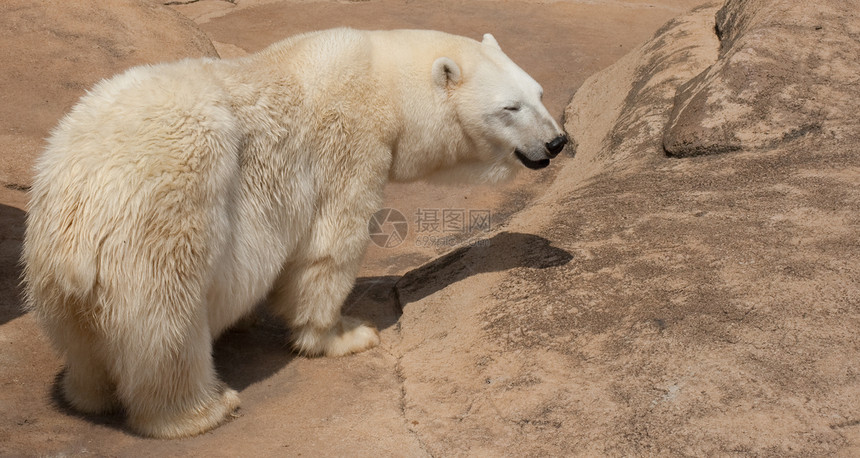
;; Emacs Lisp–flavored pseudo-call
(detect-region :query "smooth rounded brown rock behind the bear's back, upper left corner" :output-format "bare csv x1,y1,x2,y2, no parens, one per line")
0,0,218,189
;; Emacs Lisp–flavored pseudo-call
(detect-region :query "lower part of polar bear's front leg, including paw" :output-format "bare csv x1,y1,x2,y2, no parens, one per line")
270,258,379,356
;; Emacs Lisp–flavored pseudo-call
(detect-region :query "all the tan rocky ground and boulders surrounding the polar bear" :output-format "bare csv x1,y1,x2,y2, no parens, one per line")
0,0,860,456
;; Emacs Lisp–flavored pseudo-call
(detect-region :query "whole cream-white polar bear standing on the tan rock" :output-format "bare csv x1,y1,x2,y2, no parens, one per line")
23,29,566,438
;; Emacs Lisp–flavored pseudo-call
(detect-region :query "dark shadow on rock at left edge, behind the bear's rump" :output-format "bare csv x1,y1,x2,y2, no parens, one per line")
0,204,26,325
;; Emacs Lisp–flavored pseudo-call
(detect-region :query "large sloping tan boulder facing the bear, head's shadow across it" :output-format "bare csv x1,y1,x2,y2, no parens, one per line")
393,0,860,456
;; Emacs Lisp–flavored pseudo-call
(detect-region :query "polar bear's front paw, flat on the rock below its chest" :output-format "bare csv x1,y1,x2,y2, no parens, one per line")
293,316,379,356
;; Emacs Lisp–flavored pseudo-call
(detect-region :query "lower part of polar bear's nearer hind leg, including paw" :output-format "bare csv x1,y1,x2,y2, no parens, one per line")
117,314,239,439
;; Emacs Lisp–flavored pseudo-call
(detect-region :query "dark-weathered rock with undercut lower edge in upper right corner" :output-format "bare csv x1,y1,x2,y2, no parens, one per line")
663,0,860,157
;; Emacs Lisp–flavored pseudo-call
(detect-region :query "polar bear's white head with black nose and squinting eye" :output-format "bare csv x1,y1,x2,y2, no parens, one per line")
432,34,567,182
